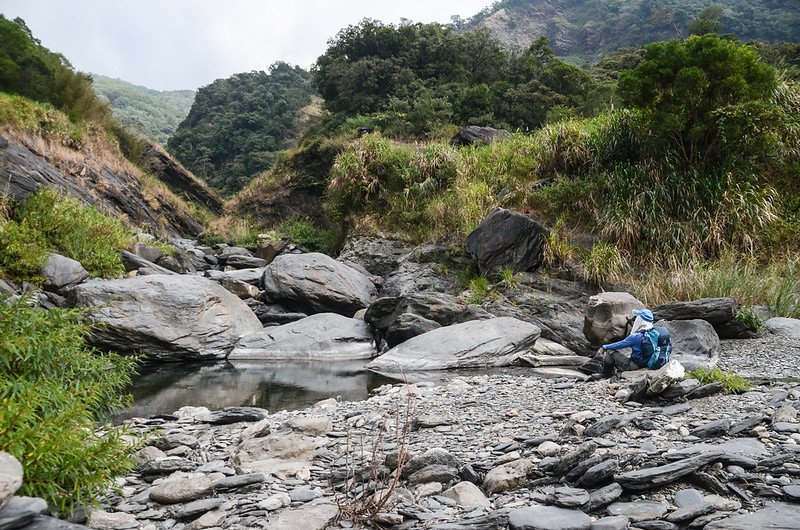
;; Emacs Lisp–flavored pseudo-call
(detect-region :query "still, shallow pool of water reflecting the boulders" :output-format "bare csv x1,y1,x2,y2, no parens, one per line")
118,361,392,420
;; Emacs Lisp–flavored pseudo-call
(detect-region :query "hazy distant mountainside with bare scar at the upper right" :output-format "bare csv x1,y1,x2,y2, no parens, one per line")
461,0,800,58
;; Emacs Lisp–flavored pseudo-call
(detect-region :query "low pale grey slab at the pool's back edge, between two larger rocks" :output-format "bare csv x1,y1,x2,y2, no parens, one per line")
228,313,378,361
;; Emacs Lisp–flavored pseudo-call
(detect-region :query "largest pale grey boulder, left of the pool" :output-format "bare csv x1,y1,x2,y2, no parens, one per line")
71,275,262,361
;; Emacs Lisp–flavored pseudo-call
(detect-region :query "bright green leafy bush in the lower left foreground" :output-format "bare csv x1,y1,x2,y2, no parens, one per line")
0,299,135,514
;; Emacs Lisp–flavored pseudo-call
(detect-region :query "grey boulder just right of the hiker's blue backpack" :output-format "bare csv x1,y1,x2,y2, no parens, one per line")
660,320,719,370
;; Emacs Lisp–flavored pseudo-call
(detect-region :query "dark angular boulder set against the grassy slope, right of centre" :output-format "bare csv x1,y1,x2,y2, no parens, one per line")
467,208,548,274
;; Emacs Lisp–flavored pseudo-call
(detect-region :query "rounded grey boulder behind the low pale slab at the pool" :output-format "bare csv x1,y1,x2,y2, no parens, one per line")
262,253,377,317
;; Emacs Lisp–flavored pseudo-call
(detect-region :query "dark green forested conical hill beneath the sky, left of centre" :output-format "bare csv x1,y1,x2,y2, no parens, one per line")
168,62,314,193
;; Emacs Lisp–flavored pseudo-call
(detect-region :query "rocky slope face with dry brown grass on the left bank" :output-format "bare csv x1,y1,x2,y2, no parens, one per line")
0,127,203,236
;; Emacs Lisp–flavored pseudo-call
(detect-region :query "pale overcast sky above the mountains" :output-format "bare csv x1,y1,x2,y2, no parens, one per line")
0,0,492,90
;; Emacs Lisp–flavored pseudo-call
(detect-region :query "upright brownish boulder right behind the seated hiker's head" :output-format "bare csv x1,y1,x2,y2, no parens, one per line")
583,293,644,346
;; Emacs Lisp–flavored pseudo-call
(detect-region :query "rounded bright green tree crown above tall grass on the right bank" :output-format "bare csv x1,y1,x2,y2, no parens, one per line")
619,34,777,167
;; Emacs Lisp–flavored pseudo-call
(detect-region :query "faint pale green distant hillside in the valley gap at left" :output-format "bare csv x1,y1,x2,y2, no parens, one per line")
92,74,195,145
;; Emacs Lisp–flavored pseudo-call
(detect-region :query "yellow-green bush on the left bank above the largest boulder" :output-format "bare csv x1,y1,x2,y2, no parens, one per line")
0,189,133,282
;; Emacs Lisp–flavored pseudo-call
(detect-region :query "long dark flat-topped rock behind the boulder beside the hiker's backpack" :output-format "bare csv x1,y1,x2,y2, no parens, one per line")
653,298,756,339
